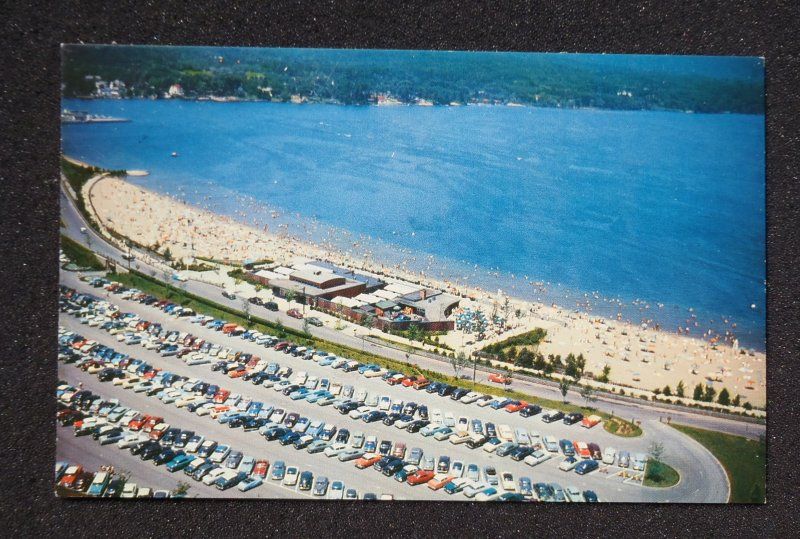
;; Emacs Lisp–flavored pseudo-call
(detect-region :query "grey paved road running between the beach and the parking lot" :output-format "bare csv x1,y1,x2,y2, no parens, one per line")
61,180,766,438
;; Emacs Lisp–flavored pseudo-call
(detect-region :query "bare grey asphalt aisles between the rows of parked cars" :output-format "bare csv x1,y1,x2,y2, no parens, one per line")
59,276,732,501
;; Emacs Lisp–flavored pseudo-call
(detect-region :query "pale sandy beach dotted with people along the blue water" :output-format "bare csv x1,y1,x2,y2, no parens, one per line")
84,177,766,407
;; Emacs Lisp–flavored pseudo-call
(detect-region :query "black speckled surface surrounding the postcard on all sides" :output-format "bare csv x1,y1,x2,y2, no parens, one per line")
0,0,800,537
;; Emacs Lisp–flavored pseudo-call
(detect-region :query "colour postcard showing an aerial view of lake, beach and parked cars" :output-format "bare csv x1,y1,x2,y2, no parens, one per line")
54,45,767,503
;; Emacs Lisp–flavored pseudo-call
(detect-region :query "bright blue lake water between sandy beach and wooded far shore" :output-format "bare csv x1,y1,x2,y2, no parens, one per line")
62,100,765,349
